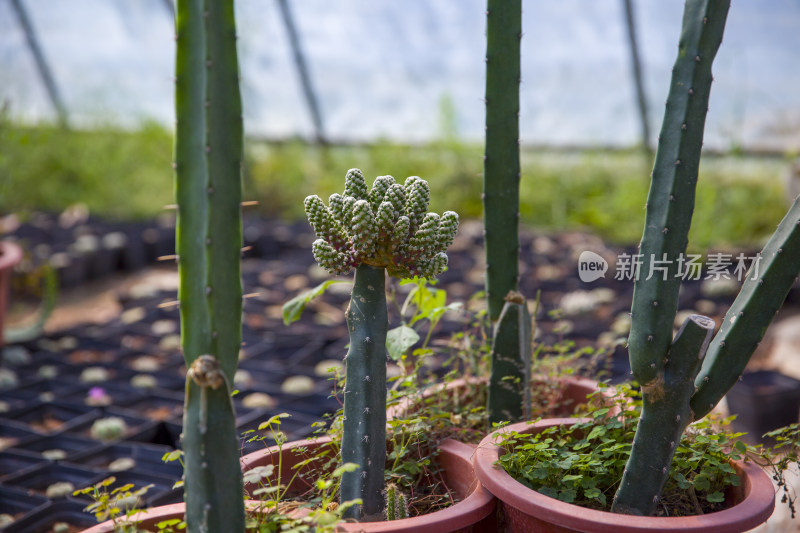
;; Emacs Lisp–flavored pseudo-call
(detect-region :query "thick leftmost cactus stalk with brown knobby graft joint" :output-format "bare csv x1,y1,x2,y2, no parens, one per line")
175,0,244,532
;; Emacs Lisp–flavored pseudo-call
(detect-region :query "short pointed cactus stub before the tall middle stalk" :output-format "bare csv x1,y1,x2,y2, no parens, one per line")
488,291,531,423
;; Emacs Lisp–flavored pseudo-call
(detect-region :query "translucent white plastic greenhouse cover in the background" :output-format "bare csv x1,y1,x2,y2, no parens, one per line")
0,0,800,150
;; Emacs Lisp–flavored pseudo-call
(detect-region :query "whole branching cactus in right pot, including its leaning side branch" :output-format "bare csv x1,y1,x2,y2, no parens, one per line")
612,0,800,515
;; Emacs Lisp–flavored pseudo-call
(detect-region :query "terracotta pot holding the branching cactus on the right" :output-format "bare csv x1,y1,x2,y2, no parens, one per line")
473,418,775,533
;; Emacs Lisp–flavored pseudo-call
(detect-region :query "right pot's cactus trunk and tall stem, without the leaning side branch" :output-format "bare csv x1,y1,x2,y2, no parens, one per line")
612,0,730,515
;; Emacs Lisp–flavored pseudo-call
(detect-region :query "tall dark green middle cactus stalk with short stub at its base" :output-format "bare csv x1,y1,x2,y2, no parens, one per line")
483,0,530,422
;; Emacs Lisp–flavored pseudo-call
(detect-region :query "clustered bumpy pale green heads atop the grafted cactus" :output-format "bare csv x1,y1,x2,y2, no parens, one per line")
305,168,458,278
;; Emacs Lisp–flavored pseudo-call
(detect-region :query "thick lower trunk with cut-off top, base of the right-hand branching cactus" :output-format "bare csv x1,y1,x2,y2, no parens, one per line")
611,315,715,516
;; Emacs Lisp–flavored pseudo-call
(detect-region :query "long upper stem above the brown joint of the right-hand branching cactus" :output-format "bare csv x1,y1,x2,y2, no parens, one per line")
628,0,730,390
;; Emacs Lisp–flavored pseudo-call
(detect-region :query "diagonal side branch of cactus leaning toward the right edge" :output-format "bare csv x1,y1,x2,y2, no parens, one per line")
691,197,800,419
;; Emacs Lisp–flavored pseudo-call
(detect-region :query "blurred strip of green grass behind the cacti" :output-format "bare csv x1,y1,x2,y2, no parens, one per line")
0,120,788,249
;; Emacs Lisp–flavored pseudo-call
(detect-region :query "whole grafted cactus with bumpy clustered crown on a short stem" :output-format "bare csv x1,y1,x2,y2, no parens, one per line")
305,169,458,521
